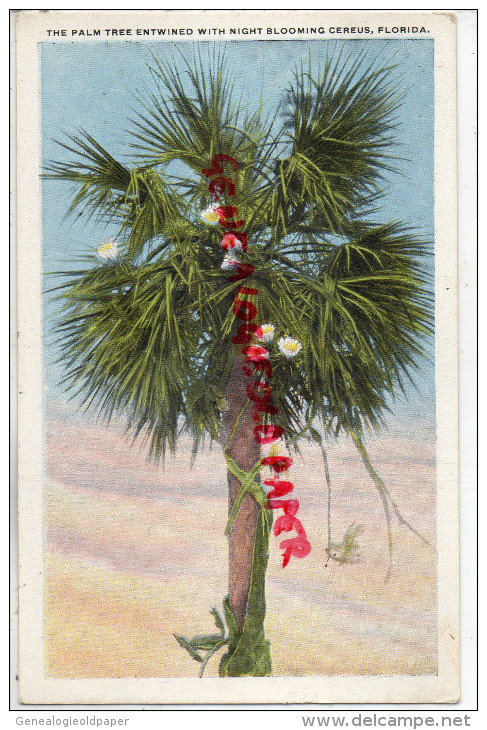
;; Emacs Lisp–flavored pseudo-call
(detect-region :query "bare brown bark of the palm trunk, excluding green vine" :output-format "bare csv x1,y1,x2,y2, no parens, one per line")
222,346,260,628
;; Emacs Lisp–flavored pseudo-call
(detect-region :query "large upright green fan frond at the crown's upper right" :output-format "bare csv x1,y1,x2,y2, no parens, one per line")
266,54,401,232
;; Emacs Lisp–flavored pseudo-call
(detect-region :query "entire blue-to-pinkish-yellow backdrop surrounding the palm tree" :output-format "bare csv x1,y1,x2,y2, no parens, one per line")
40,39,437,678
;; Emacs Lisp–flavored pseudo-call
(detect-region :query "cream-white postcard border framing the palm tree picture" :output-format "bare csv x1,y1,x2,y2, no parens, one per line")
15,10,460,705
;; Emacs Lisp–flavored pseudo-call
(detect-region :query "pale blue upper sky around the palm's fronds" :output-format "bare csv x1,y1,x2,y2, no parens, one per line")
40,39,434,425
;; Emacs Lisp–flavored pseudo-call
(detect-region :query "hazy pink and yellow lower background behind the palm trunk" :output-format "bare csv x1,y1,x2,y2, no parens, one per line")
45,398,436,678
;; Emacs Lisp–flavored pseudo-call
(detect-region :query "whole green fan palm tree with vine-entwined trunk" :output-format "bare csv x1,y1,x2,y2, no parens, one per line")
46,47,431,676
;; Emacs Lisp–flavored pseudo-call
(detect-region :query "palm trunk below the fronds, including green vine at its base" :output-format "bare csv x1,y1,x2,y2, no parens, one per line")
220,353,272,677
